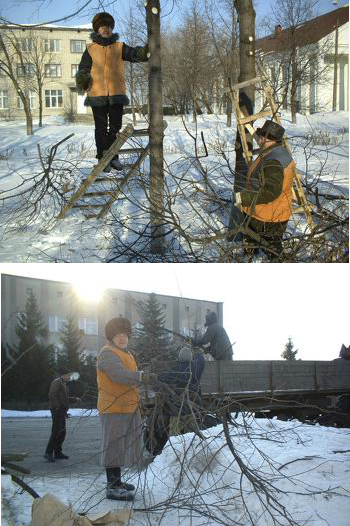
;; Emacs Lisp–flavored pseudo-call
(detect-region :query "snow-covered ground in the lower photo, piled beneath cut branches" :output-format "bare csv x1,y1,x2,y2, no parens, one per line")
1,409,350,526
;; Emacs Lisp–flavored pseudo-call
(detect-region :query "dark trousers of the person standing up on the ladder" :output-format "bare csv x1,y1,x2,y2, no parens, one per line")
91,104,123,159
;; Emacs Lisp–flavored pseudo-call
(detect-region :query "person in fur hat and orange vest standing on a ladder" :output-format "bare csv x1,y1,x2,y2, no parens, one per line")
76,13,148,172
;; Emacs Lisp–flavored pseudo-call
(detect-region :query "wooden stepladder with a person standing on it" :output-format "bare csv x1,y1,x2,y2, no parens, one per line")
57,124,149,220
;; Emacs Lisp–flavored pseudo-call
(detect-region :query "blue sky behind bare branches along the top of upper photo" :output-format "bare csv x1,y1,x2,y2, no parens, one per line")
0,0,348,26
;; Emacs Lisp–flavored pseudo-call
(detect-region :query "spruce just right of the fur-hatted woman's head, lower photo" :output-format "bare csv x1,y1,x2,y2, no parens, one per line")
130,293,175,366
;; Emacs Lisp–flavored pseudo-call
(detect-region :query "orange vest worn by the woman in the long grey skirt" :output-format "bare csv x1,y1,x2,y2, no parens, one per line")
97,345,140,413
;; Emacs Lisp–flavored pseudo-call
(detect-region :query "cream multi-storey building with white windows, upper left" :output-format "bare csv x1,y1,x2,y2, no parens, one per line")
0,25,92,119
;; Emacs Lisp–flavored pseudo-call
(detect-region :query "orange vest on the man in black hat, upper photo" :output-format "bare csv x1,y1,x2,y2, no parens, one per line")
243,146,296,223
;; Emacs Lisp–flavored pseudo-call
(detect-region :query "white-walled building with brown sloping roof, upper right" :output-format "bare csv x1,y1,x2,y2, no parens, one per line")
256,5,349,113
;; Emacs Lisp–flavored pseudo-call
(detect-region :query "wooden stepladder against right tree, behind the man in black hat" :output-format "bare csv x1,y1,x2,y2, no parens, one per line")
229,75,315,230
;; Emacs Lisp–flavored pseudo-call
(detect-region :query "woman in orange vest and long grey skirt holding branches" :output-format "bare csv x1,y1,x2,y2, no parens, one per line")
97,317,155,500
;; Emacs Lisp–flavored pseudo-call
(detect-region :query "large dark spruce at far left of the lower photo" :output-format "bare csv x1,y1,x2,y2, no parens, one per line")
4,291,53,404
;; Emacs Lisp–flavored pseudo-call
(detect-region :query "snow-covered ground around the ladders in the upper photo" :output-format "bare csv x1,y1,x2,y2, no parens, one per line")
0,112,349,262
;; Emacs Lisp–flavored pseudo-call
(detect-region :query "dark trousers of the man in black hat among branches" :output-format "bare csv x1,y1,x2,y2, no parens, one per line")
245,216,288,261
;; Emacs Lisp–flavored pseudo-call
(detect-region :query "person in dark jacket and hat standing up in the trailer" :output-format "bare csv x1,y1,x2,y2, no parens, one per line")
192,312,233,360
